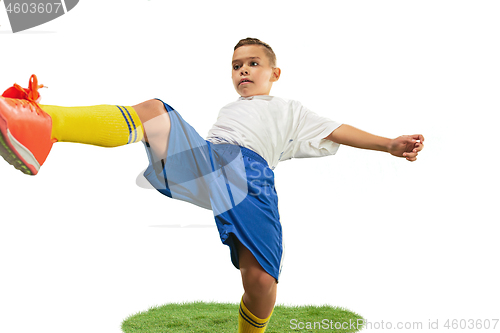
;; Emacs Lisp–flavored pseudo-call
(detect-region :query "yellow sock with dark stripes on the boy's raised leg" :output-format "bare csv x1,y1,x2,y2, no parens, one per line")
40,105,144,147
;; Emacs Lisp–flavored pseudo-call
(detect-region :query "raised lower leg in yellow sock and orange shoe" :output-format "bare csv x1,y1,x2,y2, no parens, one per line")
0,74,144,175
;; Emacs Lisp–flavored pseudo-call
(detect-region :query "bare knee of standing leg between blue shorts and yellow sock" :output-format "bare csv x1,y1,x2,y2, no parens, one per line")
238,242,278,319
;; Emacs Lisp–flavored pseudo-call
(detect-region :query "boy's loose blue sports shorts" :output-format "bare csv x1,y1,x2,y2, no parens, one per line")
144,98,283,281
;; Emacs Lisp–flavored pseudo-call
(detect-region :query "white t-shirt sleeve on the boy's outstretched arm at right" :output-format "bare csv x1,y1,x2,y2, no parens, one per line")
292,102,342,158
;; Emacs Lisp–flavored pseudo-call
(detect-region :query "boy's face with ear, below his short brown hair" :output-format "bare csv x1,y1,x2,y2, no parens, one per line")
232,45,281,97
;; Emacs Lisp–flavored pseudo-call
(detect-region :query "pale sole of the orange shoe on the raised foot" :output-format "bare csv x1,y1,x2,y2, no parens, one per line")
0,116,40,176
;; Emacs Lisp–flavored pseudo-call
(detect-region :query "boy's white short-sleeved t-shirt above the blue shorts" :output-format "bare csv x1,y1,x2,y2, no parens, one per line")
206,95,342,170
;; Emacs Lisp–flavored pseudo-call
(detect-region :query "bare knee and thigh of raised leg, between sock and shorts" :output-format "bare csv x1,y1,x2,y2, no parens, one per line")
133,99,170,160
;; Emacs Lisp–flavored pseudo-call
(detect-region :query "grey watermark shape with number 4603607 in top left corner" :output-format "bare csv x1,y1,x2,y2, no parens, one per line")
0,0,79,33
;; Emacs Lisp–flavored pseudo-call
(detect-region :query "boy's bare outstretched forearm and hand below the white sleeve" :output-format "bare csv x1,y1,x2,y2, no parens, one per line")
325,124,424,162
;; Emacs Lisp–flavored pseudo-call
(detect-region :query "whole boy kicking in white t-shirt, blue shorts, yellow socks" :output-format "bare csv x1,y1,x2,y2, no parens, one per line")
0,38,424,332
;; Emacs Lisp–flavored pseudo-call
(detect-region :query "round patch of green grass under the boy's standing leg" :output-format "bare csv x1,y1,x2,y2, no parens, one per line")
122,302,364,333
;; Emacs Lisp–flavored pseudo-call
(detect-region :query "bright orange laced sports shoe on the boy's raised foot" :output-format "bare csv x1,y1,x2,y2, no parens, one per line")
0,75,56,175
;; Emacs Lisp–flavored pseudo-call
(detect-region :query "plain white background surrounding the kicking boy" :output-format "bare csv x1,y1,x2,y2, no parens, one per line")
0,0,500,333
